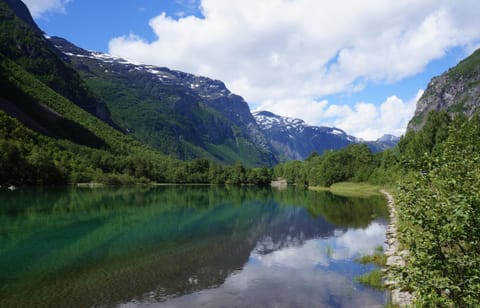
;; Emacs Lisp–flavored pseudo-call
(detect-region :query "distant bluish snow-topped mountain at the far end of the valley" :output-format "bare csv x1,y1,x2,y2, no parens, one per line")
253,111,399,161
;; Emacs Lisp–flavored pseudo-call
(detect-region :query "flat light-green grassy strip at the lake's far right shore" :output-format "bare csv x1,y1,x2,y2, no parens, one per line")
309,182,382,198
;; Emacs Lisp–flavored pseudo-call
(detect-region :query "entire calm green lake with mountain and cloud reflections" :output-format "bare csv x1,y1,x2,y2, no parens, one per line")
0,187,387,307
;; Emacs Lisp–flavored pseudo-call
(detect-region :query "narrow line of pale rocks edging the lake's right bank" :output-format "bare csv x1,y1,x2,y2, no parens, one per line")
381,189,413,307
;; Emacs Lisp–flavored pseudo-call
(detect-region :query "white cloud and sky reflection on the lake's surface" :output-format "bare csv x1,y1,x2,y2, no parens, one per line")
143,223,385,307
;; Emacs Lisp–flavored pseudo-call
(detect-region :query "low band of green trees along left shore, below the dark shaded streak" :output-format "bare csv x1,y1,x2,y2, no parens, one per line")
0,110,272,186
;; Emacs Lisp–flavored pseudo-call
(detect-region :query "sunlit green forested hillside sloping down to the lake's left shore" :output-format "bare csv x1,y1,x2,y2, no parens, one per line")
0,59,270,185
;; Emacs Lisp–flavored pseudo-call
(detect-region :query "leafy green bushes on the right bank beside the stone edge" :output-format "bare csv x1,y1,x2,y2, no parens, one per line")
398,116,480,307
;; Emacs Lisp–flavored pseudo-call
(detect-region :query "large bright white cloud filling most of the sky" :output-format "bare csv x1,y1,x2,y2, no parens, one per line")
109,0,480,138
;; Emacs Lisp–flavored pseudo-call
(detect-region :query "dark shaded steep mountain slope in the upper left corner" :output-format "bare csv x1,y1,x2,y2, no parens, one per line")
0,0,111,124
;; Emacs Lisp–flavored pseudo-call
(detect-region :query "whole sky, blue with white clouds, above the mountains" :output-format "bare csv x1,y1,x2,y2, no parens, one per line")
24,0,480,140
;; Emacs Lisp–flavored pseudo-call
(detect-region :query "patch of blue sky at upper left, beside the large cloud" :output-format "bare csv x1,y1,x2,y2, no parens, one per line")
31,0,200,52
